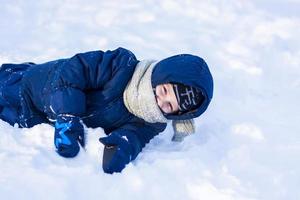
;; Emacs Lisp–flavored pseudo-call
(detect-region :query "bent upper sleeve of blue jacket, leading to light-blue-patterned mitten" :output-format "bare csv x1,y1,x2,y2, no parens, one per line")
46,48,138,116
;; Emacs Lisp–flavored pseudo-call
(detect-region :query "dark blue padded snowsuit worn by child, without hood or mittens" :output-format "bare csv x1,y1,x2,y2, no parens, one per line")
0,48,166,162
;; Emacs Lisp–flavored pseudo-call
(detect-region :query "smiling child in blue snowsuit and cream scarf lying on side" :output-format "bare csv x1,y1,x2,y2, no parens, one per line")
0,48,213,173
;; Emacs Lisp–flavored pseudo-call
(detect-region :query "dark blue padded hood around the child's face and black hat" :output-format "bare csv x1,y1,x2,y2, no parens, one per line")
151,54,213,120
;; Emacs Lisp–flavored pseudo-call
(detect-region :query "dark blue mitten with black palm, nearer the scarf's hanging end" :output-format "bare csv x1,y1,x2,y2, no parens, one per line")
99,131,139,174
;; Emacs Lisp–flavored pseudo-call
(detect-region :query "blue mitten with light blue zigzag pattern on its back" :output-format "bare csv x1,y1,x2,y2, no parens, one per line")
54,115,85,157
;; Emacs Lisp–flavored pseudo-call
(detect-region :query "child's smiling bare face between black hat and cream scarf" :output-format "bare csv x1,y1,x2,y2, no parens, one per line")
155,83,179,114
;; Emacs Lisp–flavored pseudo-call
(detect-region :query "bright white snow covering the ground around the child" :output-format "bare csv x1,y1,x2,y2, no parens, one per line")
0,0,300,200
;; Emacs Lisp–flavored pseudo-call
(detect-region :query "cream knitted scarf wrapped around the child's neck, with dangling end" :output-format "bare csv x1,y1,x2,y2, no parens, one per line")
123,60,195,141
